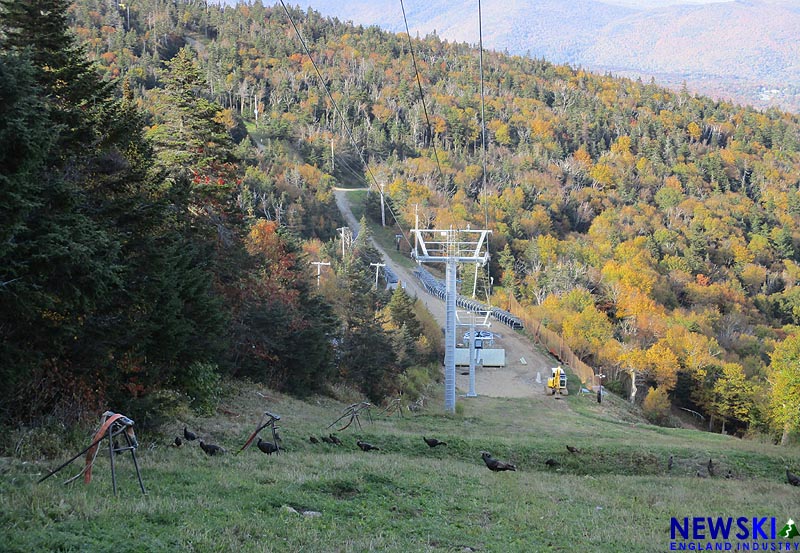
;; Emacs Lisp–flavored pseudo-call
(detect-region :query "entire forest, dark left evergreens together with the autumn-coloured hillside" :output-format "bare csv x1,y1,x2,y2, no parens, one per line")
0,0,800,440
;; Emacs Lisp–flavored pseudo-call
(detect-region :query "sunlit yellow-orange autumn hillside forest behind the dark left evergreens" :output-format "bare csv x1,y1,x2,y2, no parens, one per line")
4,0,800,439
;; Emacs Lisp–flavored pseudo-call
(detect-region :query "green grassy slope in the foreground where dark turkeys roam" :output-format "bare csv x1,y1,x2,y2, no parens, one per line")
0,386,800,552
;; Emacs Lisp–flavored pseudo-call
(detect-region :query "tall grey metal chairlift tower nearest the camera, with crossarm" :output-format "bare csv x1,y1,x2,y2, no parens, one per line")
411,225,491,413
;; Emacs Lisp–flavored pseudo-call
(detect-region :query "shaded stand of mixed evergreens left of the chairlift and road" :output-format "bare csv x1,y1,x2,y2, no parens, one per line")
0,0,436,432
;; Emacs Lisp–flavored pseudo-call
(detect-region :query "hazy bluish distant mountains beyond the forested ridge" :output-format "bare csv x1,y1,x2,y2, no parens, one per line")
284,0,800,112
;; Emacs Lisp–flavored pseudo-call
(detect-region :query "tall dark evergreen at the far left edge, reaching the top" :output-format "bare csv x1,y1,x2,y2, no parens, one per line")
0,1,128,417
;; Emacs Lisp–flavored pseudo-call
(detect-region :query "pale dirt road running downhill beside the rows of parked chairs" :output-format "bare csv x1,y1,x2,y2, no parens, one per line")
335,189,554,399
